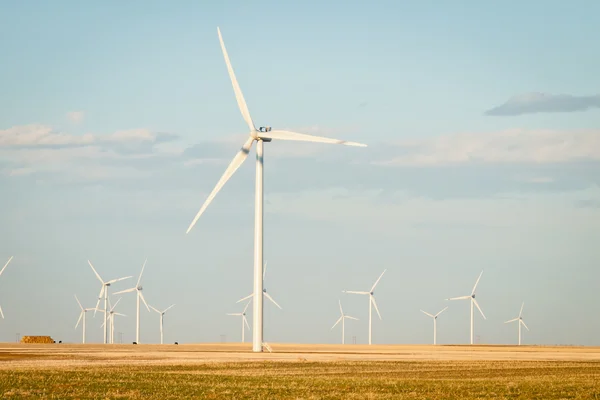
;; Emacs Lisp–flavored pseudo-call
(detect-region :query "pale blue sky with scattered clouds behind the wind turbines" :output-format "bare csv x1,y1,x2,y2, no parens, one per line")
0,1,600,345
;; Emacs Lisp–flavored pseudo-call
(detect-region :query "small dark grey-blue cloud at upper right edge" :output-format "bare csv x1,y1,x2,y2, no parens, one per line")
484,93,600,116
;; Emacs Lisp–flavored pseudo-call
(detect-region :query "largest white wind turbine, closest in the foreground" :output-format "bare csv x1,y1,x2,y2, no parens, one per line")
186,28,366,352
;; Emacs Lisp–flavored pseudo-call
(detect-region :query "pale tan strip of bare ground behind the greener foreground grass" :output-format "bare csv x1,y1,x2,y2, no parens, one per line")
0,343,600,370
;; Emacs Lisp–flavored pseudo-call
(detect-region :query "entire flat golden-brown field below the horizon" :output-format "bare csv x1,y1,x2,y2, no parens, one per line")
0,343,600,399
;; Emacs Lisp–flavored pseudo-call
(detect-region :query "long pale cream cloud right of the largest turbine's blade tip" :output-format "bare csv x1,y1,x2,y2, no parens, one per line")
375,129,600,167
